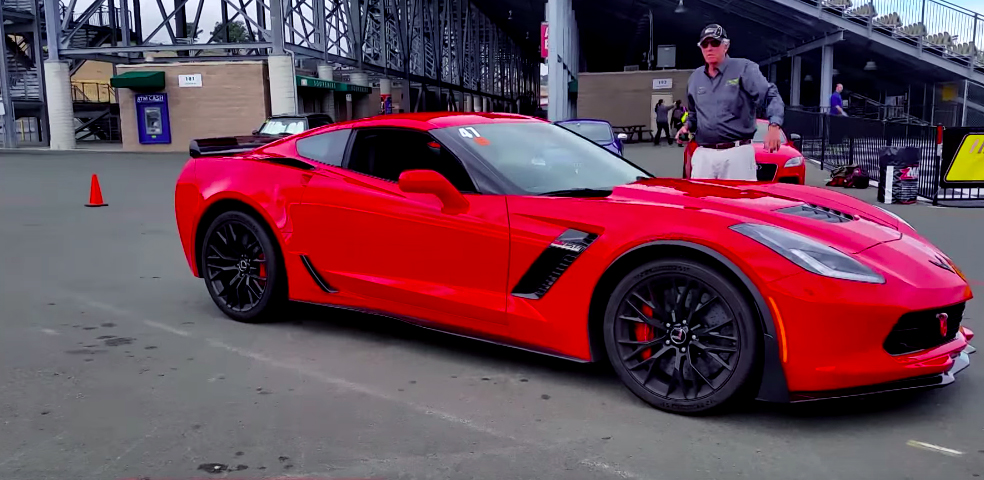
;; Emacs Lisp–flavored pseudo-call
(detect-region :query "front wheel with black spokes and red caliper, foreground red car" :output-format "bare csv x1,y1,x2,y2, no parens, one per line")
604,258,762,415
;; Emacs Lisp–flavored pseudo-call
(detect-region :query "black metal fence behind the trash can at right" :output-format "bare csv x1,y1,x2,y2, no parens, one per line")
784,108,984,205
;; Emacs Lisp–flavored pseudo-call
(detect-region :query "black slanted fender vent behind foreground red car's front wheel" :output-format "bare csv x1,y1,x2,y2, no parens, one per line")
512,229,598,300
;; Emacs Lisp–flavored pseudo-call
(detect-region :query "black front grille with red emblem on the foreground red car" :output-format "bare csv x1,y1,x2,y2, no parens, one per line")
884,303,966,355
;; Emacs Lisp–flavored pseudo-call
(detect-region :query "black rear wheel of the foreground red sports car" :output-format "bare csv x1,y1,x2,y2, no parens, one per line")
201,211,287,323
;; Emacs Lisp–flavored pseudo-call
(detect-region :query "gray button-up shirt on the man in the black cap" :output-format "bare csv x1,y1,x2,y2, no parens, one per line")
687,57,785,145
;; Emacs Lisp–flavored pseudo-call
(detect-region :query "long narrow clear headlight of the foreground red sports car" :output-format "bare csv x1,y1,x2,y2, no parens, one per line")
731,223,885,283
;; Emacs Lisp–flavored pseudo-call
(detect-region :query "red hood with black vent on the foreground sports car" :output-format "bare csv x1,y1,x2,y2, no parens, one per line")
607,178,902,253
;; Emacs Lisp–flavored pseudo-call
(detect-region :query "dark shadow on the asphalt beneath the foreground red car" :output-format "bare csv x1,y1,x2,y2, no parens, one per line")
266,303,961,431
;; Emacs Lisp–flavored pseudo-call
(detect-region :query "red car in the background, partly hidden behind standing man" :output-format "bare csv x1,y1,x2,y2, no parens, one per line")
683,120,806,185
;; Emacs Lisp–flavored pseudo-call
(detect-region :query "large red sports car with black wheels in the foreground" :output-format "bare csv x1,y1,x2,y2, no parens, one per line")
175,113,973,413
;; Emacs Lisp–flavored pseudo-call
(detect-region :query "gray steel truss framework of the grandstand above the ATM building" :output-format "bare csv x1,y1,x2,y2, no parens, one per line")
50,0,540,102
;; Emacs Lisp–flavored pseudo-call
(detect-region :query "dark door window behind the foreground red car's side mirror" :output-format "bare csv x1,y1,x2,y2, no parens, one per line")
348,129,478,193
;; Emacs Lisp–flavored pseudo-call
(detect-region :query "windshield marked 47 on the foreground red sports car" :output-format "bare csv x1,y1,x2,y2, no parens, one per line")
431,123,652,194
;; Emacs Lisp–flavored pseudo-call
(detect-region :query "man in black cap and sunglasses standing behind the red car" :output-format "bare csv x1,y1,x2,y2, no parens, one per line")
677,24,785,181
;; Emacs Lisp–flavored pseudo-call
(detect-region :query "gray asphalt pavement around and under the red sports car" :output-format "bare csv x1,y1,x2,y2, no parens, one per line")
0,144,984,480
